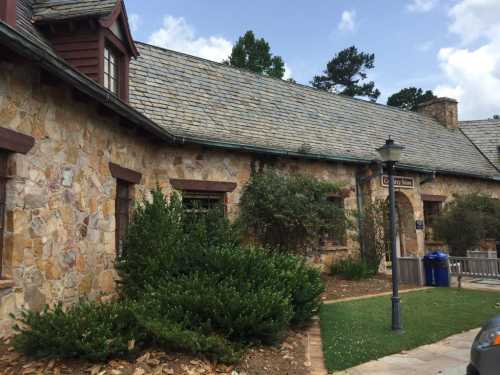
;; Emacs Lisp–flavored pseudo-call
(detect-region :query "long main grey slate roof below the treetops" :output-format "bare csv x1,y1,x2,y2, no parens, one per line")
130,43,498,176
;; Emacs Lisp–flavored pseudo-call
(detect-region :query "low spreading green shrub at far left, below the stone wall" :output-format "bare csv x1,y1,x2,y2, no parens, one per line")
12,302,144,361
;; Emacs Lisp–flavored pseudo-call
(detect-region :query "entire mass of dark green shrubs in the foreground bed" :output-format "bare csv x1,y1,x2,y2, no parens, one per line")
15,190,323,363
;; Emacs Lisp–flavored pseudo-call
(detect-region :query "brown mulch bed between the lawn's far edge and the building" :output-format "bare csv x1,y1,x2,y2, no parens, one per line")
323,275,417,301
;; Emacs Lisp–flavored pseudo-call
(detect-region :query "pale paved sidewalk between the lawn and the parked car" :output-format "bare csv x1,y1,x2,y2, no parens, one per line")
335,329,479,375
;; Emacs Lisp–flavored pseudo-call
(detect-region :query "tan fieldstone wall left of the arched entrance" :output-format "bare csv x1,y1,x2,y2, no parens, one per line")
0,62,357,335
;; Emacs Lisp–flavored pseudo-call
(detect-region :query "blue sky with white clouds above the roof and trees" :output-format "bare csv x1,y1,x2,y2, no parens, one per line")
126,0,500,120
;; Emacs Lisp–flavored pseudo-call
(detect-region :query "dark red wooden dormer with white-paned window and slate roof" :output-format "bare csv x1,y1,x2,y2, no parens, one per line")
31,0,139,102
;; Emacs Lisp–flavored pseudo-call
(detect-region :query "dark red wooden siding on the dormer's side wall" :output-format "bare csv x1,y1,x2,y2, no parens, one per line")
50,30,100,82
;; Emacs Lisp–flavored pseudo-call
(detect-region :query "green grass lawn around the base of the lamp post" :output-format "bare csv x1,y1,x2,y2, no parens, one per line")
321,288,500,371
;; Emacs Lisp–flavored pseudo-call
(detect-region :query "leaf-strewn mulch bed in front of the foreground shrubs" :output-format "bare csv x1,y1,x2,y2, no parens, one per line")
0,332,310,375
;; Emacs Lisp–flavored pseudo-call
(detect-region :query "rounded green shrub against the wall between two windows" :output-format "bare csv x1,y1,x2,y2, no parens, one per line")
240,169,350,254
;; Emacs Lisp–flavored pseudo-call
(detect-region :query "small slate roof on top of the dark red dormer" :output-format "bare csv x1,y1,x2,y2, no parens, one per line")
33,0,118,21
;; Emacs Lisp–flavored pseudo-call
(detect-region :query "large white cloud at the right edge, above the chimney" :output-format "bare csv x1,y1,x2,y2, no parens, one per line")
435,0,500,119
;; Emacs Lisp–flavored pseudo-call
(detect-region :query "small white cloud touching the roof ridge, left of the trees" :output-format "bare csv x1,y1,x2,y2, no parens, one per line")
149,16,233,62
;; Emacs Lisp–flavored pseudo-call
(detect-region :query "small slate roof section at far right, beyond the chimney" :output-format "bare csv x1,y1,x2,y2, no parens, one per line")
460,120,500,168
